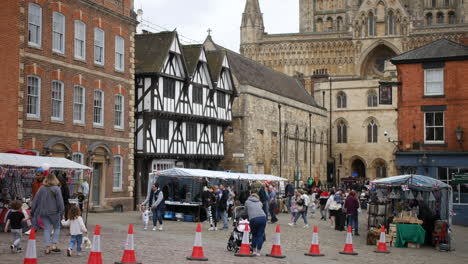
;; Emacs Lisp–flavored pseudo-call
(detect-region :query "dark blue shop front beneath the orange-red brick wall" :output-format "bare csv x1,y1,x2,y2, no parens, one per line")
396,152,468,226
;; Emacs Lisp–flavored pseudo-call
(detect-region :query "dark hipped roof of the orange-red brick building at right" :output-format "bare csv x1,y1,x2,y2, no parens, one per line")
390,38,468,64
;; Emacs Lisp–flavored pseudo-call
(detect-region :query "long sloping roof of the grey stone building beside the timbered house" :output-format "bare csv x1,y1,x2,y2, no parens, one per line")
222,50,319,107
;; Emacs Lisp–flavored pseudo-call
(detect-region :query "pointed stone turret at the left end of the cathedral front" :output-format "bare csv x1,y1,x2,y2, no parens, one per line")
241,0,265,45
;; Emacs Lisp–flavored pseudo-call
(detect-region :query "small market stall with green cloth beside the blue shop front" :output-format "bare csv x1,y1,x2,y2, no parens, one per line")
368,175,452,250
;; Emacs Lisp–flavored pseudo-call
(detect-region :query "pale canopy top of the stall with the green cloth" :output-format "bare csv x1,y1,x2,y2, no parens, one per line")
372,174,451,191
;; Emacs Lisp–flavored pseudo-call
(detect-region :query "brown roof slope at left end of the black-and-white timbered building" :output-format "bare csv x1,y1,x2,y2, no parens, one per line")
135,31,177,73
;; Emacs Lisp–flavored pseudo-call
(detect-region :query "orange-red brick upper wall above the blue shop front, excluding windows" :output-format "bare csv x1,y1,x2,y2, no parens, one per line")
397,60,468,151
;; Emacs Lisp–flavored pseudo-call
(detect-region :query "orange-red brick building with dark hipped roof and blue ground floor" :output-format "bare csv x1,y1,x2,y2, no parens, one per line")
392,39,468,224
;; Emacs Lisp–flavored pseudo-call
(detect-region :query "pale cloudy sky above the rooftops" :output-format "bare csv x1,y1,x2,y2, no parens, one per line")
135,0,299,51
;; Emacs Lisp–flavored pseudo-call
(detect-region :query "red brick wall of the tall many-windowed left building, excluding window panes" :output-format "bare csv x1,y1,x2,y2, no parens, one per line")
0,0,136,209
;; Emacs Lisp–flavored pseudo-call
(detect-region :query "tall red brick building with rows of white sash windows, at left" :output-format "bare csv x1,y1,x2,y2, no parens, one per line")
0,0,137,209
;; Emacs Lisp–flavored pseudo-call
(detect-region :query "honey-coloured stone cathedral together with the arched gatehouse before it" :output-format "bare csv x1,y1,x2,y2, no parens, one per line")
240,0,468,183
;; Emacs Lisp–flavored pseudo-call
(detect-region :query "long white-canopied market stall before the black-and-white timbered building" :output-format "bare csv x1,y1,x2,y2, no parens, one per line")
148,168,286,221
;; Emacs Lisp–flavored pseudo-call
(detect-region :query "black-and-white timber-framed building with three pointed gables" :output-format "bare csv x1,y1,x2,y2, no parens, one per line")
135,32,235,195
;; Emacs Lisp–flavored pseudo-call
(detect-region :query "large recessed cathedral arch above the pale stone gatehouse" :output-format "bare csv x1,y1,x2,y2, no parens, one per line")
361,44,397,77
